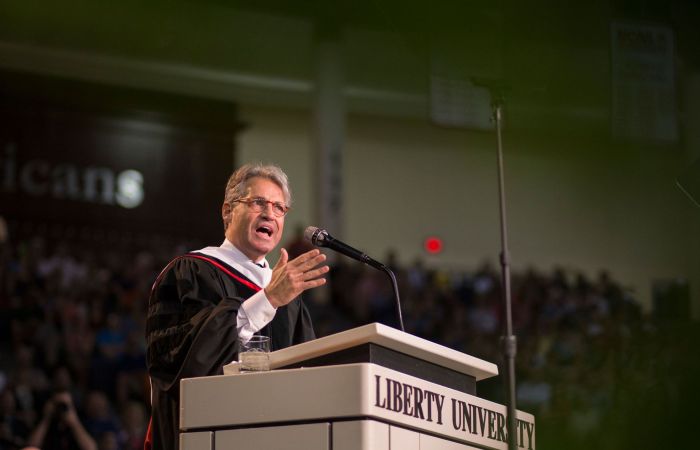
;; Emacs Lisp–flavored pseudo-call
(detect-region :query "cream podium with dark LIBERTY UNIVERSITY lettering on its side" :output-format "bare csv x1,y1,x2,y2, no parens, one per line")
180,323,535,450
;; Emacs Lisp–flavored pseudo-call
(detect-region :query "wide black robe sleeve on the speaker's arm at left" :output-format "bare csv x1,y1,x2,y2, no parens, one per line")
146,258,245,395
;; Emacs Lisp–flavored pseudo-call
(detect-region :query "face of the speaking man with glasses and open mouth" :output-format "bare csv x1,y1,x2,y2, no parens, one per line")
221,177,286,261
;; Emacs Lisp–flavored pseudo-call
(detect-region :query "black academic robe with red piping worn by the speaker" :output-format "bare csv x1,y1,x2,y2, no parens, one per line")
146,253,315,450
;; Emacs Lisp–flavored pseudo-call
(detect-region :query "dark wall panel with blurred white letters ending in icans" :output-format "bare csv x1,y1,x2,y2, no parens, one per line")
0,81,236,242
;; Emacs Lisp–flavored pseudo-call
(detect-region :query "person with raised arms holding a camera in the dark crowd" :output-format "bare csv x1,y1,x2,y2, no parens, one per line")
28,391,97,450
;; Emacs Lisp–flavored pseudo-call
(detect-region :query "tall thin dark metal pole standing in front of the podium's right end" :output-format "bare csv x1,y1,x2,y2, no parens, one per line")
493,99,517,450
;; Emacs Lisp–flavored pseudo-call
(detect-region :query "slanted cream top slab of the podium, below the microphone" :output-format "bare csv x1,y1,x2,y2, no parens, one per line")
270,323,498,381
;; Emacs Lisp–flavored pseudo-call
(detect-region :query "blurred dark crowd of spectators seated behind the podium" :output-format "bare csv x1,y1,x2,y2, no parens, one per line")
0,223,696,450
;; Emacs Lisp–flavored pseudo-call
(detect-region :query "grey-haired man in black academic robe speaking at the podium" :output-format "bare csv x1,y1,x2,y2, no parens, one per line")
145,164,328,450
